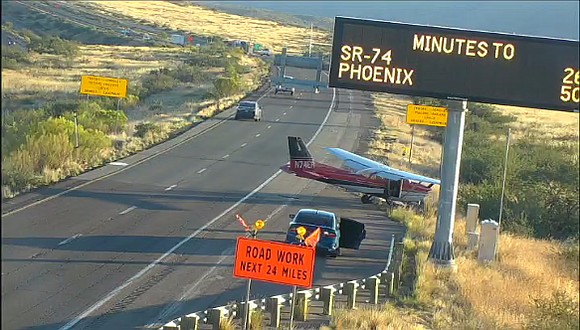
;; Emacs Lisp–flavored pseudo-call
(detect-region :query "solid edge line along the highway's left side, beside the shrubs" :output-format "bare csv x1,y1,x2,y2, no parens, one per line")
1,87,274,218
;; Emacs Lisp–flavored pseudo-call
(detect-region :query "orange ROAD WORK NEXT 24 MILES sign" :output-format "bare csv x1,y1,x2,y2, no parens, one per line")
234,237,316,288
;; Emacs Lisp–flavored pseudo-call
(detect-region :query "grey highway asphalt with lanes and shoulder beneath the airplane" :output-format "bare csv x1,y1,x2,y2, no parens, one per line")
2,68,401,329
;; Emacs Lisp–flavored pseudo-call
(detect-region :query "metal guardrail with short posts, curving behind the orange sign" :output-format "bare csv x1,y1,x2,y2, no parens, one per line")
158,234,402,330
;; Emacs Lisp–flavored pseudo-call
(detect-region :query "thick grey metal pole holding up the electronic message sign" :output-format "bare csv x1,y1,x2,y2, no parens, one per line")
429,99,467,269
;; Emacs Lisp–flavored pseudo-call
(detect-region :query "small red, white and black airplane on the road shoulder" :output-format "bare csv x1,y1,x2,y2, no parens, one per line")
281,136,440,205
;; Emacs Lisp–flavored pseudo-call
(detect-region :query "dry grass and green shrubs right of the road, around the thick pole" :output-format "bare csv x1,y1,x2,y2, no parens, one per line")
322,94,580,329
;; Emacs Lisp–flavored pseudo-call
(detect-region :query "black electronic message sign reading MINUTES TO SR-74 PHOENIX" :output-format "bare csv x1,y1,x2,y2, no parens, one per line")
329,17,580,111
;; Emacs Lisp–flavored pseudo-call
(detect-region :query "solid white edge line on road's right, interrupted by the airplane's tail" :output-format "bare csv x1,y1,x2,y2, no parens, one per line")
59,88,336,330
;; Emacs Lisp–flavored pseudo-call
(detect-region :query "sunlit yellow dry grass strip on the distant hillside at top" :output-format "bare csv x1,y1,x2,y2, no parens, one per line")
91,1,328,52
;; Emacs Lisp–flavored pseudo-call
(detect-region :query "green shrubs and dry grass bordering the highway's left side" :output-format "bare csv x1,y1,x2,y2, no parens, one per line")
2,23,269,198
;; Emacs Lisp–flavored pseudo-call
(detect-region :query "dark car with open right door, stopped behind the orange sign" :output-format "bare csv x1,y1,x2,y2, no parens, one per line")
286,209,366,257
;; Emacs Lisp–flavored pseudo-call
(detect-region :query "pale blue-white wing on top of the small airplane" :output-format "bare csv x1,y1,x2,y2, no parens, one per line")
326,148,441,184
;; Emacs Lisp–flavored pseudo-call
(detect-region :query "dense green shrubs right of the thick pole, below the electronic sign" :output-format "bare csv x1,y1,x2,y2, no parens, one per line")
459,99,580,238
